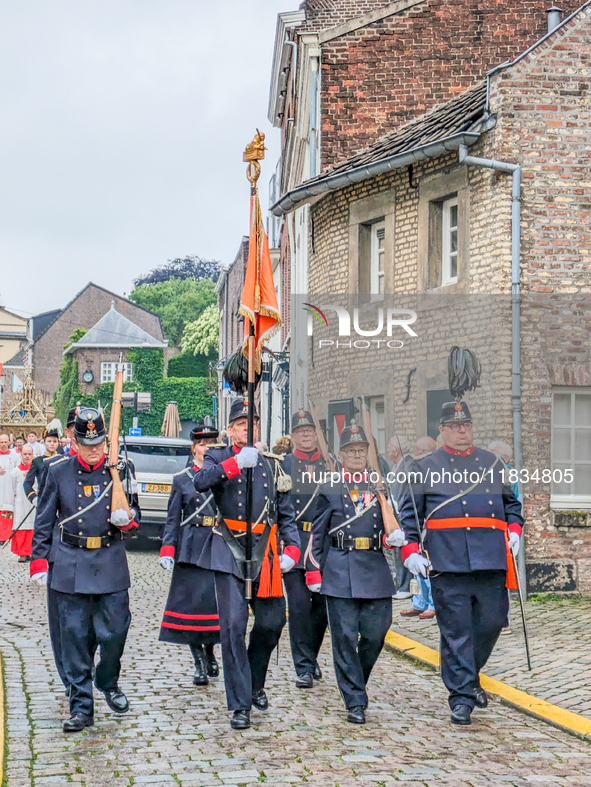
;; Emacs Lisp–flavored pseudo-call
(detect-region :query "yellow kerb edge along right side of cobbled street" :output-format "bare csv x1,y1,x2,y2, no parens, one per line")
385,631,591,742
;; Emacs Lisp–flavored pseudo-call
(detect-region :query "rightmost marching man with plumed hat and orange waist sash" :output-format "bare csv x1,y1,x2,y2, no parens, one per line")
400,402,523,724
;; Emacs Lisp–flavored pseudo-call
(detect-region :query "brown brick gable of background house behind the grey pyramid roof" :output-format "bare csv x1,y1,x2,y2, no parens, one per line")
33,284,165,394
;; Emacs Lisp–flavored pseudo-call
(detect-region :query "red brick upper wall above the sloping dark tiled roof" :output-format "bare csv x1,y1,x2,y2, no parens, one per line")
316,0,580,169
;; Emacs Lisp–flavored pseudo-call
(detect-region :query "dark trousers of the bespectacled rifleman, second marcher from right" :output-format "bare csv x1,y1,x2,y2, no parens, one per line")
326,596,392,708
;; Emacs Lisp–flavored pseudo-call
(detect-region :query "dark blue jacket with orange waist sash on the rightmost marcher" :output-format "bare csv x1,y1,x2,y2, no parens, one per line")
399,447,523,573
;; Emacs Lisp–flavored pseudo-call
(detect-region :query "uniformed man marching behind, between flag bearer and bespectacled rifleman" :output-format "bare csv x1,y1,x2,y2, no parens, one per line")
283,410,328,689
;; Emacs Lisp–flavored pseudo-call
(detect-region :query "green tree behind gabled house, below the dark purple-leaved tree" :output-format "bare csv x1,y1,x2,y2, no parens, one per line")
129,279,216,347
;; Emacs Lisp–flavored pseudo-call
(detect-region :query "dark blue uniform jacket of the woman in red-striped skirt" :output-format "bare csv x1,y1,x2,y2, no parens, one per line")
160,466,216,566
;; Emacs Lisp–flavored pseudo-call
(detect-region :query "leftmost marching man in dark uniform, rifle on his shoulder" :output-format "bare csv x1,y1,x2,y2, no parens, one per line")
31,408,139,732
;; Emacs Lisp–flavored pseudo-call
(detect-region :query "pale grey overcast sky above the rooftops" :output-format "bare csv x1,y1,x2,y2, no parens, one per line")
0,0,292,316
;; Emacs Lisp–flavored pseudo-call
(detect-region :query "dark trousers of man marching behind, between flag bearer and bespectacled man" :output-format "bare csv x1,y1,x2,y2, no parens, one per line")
283,568,328,675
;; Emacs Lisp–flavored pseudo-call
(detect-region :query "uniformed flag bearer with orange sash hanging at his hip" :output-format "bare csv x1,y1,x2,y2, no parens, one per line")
194,398,300,729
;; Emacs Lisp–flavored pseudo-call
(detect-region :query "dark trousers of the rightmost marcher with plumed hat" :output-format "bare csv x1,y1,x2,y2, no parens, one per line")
431,571,509,709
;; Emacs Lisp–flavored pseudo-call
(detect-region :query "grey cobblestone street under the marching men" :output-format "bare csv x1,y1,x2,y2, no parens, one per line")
0,550,591,787
